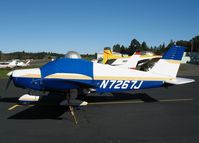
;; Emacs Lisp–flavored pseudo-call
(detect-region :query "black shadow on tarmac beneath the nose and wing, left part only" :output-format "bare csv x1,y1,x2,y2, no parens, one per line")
0,93,69,120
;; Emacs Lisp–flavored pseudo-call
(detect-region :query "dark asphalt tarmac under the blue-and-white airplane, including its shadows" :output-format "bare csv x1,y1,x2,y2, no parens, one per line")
0,65,199,143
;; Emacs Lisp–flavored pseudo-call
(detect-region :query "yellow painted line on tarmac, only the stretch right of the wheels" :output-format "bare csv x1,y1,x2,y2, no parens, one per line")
88,98,193,105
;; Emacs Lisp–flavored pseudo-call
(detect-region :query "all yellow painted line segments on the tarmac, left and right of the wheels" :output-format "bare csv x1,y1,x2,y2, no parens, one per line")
8,98,193,111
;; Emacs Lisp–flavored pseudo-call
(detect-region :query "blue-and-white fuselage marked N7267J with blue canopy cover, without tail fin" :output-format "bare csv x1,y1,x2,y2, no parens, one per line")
12,58,170,92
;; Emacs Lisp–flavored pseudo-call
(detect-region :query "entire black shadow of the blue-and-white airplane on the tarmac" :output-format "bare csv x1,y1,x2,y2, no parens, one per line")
0,93,157,120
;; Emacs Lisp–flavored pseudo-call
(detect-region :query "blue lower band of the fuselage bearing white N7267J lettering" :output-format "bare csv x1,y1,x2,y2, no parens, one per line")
13,77,164,92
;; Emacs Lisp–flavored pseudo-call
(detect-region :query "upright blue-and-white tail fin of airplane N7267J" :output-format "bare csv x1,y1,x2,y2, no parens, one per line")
149,46,185,77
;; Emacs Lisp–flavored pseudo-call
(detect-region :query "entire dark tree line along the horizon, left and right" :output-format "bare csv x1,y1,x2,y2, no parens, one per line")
0,35,199,60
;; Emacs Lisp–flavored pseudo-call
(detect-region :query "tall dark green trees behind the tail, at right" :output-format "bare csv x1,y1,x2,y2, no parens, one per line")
110,36,199,55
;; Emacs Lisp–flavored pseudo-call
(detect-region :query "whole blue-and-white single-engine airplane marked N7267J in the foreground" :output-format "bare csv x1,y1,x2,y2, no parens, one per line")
7,46,194,123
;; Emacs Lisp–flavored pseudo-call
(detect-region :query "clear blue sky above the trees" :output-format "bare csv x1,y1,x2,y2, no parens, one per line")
0,0,199,53
